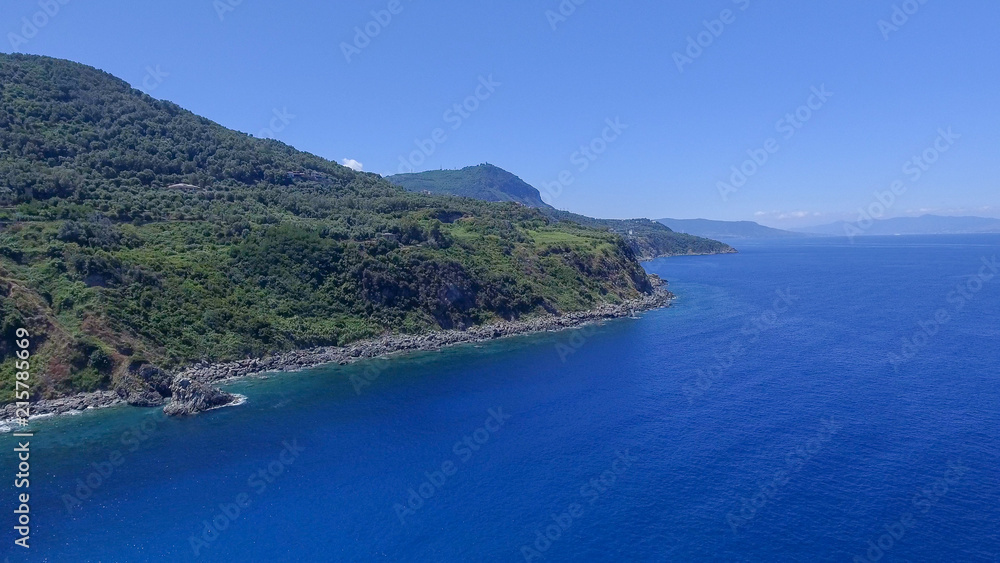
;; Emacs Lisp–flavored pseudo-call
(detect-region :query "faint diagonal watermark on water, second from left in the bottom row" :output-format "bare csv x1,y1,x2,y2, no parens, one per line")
188,440,305,557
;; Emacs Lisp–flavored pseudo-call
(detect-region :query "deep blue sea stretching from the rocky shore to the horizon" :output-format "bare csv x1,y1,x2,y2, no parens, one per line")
0,236,1000,562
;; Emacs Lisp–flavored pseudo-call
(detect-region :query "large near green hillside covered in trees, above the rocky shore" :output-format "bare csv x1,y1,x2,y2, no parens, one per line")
0,54,651,400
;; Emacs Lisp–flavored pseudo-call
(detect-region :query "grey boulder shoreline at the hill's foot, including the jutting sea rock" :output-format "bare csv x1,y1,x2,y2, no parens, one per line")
0,284,674,428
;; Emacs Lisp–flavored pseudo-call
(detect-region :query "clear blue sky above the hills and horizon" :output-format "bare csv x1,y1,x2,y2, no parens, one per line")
0,0,1000,227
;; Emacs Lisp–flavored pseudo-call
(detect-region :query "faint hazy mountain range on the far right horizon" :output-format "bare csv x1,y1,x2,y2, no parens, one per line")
796,215,1000,236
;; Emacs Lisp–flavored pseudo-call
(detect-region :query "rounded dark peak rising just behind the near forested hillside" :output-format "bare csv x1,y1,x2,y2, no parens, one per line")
386,164,552,209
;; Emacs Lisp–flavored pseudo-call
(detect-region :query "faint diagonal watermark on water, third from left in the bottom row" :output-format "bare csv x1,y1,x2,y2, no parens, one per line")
392,407,510,526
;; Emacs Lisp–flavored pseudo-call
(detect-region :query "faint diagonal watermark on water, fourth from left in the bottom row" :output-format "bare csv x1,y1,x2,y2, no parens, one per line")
520,449,639,563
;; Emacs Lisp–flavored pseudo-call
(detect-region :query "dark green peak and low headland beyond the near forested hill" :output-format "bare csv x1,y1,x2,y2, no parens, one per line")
387,164,736,260
